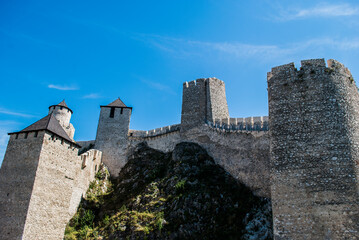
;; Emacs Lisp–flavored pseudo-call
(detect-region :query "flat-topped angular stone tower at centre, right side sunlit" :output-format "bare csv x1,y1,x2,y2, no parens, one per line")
181,78,229,131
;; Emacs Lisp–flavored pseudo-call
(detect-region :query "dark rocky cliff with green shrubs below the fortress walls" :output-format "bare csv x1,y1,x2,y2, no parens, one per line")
65,142,272,239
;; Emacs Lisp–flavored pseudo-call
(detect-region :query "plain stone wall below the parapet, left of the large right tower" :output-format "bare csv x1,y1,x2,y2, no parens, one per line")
181,124,270,197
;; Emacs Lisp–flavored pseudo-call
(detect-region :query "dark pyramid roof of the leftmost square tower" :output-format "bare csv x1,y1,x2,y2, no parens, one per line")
9,114,79,146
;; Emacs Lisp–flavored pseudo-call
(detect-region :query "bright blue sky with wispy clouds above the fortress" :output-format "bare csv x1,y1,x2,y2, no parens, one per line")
0,0,359,162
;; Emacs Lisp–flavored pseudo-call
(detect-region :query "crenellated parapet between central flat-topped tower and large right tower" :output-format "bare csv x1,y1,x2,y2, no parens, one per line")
207,116,269,131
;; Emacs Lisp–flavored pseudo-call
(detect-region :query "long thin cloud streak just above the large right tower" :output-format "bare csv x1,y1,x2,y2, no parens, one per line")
142,35,359,61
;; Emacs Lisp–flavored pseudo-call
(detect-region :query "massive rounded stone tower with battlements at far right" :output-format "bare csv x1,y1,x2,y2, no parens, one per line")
268,59,359,239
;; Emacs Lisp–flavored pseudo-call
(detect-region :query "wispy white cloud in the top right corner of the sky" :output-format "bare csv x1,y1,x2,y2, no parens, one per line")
277,3,359,21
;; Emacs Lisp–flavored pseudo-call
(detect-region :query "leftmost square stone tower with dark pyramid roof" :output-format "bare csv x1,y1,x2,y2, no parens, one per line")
0,102,81,240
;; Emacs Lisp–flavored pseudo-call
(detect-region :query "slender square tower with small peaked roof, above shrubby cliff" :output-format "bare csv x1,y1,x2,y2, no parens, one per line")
95,98,132,176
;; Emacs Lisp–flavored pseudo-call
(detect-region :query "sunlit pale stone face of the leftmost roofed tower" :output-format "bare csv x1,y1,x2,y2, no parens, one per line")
23,132,81,239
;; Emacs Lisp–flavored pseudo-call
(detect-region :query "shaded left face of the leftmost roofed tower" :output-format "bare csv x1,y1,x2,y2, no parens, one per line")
0,131,44,240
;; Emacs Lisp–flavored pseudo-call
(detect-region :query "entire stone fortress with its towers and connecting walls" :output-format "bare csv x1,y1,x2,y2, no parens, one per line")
0,59,359,239
